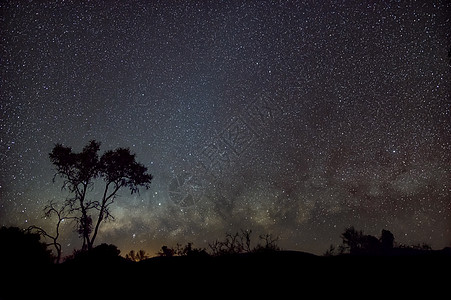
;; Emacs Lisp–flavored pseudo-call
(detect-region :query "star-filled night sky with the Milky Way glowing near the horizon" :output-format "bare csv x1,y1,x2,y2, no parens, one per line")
0,0,451,255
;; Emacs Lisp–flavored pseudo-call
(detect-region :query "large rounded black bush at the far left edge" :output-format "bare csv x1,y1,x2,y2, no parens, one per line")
0,226,53,266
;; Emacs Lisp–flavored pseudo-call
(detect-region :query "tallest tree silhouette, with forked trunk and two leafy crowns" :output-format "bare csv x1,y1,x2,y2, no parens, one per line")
49,140,152,250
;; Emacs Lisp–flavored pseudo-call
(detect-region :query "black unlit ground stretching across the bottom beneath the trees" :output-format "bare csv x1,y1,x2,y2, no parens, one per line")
0,249,451,299
